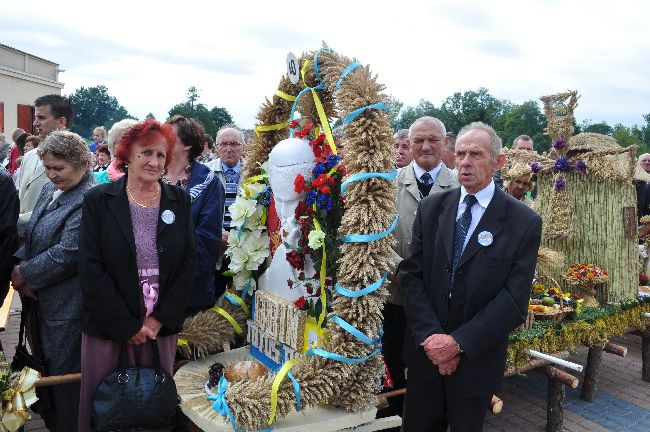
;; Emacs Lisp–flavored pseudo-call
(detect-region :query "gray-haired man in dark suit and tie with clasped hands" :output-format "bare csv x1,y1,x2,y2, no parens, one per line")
400,122,542,432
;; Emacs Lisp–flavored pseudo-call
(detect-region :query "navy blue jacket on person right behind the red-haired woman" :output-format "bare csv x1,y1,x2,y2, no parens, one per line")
187,161,225,308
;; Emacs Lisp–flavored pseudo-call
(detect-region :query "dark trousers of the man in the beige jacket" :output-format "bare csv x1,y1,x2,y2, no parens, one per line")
378,302,406,417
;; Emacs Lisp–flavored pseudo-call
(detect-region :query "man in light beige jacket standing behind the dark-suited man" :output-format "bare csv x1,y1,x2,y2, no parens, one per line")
382,117,459,415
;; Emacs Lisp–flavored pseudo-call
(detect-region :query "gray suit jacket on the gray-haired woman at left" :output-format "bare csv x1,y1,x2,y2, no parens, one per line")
15,173,97,321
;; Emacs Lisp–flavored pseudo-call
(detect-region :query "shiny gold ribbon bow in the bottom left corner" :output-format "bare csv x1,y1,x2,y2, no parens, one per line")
2,367,41,432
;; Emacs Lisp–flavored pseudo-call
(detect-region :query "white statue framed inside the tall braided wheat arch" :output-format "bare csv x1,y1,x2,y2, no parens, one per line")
258,138,318,302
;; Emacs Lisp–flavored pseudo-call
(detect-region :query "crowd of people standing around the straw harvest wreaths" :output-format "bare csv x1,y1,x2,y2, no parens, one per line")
0,95,650,431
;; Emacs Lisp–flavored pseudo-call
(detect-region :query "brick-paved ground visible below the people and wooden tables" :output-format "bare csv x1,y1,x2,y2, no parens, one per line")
0,296,650,432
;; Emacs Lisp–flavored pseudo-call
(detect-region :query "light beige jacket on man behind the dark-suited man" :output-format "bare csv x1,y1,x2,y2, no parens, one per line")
388,162,460,305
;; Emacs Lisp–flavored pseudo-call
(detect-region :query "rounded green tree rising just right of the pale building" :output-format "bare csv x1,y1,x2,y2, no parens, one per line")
69,85,135,137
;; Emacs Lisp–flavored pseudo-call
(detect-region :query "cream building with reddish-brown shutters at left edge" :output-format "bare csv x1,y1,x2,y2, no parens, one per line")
0,44,63,141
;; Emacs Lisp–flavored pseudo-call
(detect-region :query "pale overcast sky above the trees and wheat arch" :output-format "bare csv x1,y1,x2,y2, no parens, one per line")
0,0,650,128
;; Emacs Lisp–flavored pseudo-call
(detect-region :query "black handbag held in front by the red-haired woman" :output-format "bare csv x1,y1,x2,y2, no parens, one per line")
90,339,179,432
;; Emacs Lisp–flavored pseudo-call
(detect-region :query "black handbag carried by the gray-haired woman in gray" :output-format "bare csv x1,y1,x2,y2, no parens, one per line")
11,298,55,418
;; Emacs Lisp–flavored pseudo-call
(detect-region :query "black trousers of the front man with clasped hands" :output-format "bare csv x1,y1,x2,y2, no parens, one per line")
402,373,492,432
